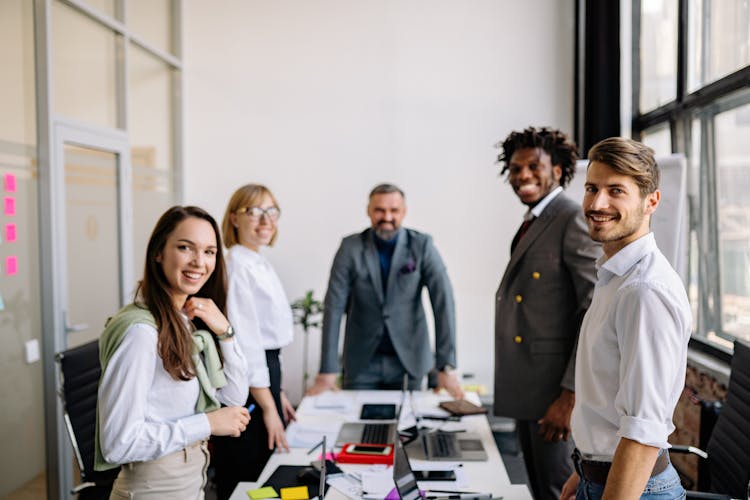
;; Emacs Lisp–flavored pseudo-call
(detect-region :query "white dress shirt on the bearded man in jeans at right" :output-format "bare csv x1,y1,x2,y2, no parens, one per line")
572,233,691,461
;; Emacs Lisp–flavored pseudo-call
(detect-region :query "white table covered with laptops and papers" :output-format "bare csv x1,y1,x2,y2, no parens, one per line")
230,391,531,500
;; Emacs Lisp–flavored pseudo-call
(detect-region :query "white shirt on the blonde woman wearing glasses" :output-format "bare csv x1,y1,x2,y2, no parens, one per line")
227,245,294,387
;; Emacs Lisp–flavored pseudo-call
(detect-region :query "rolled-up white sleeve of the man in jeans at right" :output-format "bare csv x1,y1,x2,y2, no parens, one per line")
615,283,685,448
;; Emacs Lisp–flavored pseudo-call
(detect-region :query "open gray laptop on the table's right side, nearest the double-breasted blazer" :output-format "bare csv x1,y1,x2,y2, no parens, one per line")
410,394,488,462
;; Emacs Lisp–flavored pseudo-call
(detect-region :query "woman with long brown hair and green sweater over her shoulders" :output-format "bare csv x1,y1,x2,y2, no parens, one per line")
95,206,250,498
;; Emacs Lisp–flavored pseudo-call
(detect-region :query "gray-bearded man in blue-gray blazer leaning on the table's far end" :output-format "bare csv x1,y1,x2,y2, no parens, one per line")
308,184,463,398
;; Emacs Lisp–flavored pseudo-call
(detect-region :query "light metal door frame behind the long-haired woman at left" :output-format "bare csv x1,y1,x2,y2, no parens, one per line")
40,117,134,499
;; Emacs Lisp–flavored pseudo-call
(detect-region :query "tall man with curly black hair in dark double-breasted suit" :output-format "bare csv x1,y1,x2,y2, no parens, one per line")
494,127,601,500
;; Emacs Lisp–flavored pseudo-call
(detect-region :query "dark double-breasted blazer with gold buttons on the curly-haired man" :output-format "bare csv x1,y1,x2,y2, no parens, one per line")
494,193,602,420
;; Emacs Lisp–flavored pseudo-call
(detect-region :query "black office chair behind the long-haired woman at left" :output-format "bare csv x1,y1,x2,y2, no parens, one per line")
55,340,120,500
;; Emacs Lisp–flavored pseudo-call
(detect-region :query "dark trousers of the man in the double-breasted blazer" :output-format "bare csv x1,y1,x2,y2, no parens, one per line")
516,420,575,500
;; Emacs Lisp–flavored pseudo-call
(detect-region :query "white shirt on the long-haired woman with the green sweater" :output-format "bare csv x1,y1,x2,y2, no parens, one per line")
99,323,247,464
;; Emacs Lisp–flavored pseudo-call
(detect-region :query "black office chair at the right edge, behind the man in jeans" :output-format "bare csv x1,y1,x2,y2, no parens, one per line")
670,340,750,499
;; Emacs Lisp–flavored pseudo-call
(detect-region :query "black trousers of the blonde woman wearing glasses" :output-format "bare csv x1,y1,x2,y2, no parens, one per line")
211,349,284,500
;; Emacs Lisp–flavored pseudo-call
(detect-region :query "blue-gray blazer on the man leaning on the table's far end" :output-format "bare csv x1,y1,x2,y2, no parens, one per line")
320,228,456,377
